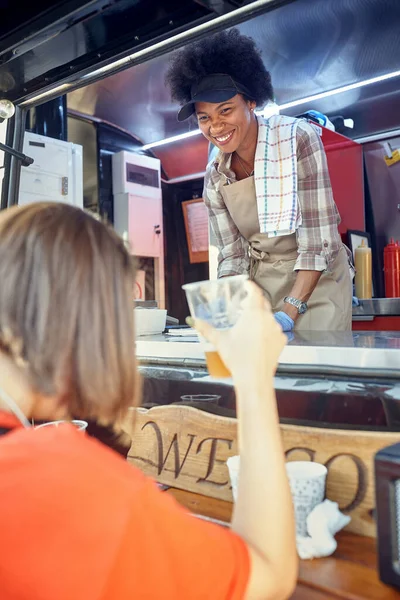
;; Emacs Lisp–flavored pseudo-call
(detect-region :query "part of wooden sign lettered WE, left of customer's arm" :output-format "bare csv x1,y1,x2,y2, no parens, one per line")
124,406,238,501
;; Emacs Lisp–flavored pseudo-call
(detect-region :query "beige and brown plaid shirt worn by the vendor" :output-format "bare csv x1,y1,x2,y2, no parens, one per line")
203,121,343,277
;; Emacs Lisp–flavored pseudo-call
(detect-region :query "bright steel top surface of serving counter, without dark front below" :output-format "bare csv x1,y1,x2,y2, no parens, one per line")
137,331,400,379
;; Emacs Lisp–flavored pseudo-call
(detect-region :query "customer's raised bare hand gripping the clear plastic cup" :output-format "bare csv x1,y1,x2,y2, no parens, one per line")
190,281,287,381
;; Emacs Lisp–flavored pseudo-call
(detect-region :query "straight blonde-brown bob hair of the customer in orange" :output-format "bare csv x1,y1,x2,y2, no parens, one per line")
0,202,137,419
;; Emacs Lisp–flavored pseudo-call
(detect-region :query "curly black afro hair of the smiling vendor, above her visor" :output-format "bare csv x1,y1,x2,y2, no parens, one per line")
165,28,274,106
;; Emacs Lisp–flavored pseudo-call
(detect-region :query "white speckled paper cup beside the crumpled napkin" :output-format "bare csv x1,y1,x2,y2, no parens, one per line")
286,461,328,536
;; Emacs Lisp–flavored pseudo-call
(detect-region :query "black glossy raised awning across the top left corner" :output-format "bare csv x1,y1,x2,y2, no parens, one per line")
0,0,289,103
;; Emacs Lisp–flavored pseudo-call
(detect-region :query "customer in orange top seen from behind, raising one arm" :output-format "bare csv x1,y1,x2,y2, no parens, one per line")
0,203,297,600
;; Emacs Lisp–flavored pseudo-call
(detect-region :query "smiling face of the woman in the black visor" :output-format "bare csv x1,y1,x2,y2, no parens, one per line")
196,94,257,154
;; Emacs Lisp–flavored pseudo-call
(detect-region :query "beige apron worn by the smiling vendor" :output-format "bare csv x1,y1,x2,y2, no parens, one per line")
219,177,352,331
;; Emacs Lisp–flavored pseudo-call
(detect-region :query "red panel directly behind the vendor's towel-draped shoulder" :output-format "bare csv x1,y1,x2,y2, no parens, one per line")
321,127,365,234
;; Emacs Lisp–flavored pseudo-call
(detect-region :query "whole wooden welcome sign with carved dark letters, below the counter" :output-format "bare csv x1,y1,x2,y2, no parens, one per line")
125,405,400,537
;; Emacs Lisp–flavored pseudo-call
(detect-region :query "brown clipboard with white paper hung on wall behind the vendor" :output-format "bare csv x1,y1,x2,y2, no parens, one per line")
182,198,208,263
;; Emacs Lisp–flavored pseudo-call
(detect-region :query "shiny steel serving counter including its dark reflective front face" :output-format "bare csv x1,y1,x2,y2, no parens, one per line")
137,332,400,431
